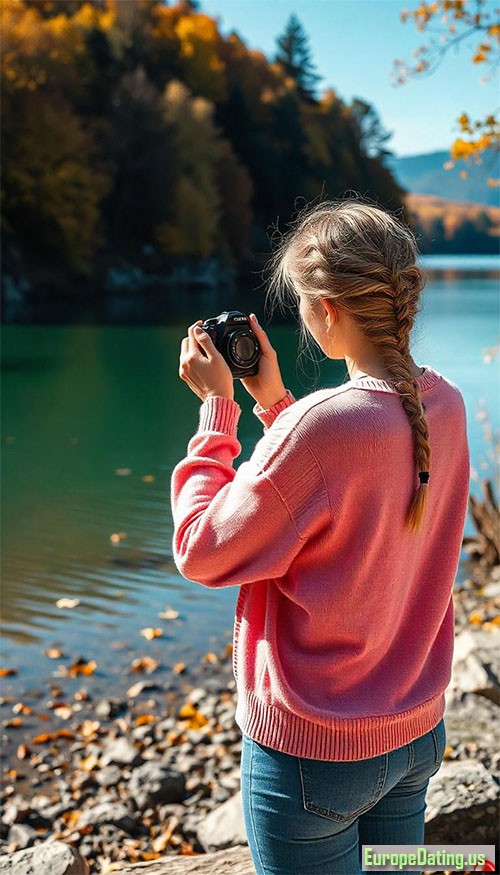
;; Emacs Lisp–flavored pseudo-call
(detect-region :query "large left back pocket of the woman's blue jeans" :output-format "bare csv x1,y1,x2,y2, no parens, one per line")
297,753,388,823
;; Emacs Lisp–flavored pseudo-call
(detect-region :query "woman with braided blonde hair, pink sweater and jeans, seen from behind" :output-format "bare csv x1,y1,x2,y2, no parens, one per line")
171,200,470,875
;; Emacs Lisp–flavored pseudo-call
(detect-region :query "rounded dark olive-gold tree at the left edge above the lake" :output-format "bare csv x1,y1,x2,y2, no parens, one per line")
2,93,109,273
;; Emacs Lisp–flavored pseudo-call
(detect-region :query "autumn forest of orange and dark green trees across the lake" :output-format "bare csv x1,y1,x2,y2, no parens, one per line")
1,0,495,302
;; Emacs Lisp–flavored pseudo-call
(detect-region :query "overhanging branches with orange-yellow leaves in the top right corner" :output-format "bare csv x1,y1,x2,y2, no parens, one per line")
391,0,500,185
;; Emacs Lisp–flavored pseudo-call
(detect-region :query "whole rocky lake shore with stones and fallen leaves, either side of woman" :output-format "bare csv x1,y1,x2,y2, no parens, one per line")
0,565,500,875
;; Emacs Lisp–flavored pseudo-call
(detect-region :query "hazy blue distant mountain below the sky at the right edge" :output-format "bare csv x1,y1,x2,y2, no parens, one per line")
384,149,500,206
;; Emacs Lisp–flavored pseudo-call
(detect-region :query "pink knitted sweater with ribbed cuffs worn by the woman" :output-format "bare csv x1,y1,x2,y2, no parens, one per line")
171,365,470,760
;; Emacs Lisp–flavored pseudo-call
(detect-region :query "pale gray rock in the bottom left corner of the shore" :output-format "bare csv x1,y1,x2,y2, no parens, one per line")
0,841,89,875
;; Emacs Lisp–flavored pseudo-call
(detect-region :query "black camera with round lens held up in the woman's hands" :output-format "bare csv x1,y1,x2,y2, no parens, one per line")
201,310,261,378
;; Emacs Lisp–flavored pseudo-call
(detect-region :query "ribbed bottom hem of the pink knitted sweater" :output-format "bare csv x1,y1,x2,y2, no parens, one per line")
235,690,445,762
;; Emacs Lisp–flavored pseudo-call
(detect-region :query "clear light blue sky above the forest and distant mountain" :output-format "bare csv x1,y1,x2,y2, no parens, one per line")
201,0,498,156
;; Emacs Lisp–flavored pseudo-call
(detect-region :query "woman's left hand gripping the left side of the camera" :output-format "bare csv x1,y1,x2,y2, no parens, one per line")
179,319,234,401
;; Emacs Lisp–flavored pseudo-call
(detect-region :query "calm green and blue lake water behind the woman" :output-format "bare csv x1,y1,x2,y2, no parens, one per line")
1,256,500,689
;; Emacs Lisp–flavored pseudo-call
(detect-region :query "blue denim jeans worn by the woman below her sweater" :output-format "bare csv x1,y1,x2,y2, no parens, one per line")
241,719,446,875
